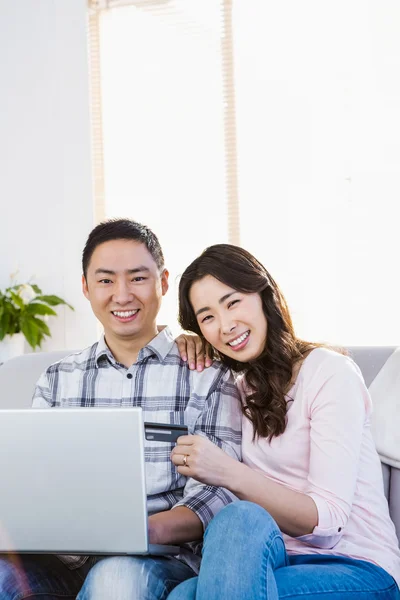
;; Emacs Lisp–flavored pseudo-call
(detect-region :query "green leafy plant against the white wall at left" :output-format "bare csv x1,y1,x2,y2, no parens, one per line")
0,283,74,348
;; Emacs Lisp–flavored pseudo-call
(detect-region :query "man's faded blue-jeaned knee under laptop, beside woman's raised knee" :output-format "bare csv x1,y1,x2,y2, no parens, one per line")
77,556,195,600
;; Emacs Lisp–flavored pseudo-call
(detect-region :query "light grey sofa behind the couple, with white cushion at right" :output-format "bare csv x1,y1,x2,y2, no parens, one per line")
0,346,400,540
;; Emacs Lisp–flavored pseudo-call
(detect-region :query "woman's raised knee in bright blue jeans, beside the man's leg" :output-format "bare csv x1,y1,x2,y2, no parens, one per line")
187,501,288,600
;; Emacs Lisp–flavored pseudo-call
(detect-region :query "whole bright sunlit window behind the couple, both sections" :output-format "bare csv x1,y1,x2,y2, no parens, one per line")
92,0,400,345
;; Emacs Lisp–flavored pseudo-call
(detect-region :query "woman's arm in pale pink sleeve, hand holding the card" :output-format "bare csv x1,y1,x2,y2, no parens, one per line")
173,355,370,548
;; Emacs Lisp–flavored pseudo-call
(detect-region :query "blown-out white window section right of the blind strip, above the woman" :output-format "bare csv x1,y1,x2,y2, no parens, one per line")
234,0,400,345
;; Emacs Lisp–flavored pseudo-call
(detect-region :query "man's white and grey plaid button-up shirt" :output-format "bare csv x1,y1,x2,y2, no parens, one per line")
33,328,241,569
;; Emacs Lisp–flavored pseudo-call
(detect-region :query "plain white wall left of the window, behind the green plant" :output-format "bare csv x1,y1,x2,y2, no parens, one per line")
0,0,97,349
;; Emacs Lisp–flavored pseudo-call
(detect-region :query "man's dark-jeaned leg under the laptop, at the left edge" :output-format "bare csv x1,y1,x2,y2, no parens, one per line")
0,555,83,600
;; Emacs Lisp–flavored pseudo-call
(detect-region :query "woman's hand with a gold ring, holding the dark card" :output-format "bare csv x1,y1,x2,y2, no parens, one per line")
171,435,240,488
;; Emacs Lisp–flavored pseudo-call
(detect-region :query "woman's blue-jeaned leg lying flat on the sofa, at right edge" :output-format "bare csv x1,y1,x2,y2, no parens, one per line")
276,554,400,600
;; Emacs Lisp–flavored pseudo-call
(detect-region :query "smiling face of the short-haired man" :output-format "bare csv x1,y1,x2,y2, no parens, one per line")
82,240,168,347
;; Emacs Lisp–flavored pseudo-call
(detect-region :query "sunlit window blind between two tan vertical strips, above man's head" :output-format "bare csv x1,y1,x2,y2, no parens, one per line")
89,0,240,330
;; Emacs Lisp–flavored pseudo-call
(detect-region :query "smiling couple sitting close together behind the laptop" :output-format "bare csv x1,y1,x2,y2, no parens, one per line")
0,220,400,600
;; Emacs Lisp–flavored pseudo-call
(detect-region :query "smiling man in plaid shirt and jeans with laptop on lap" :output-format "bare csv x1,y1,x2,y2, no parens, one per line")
0,219,241,600
